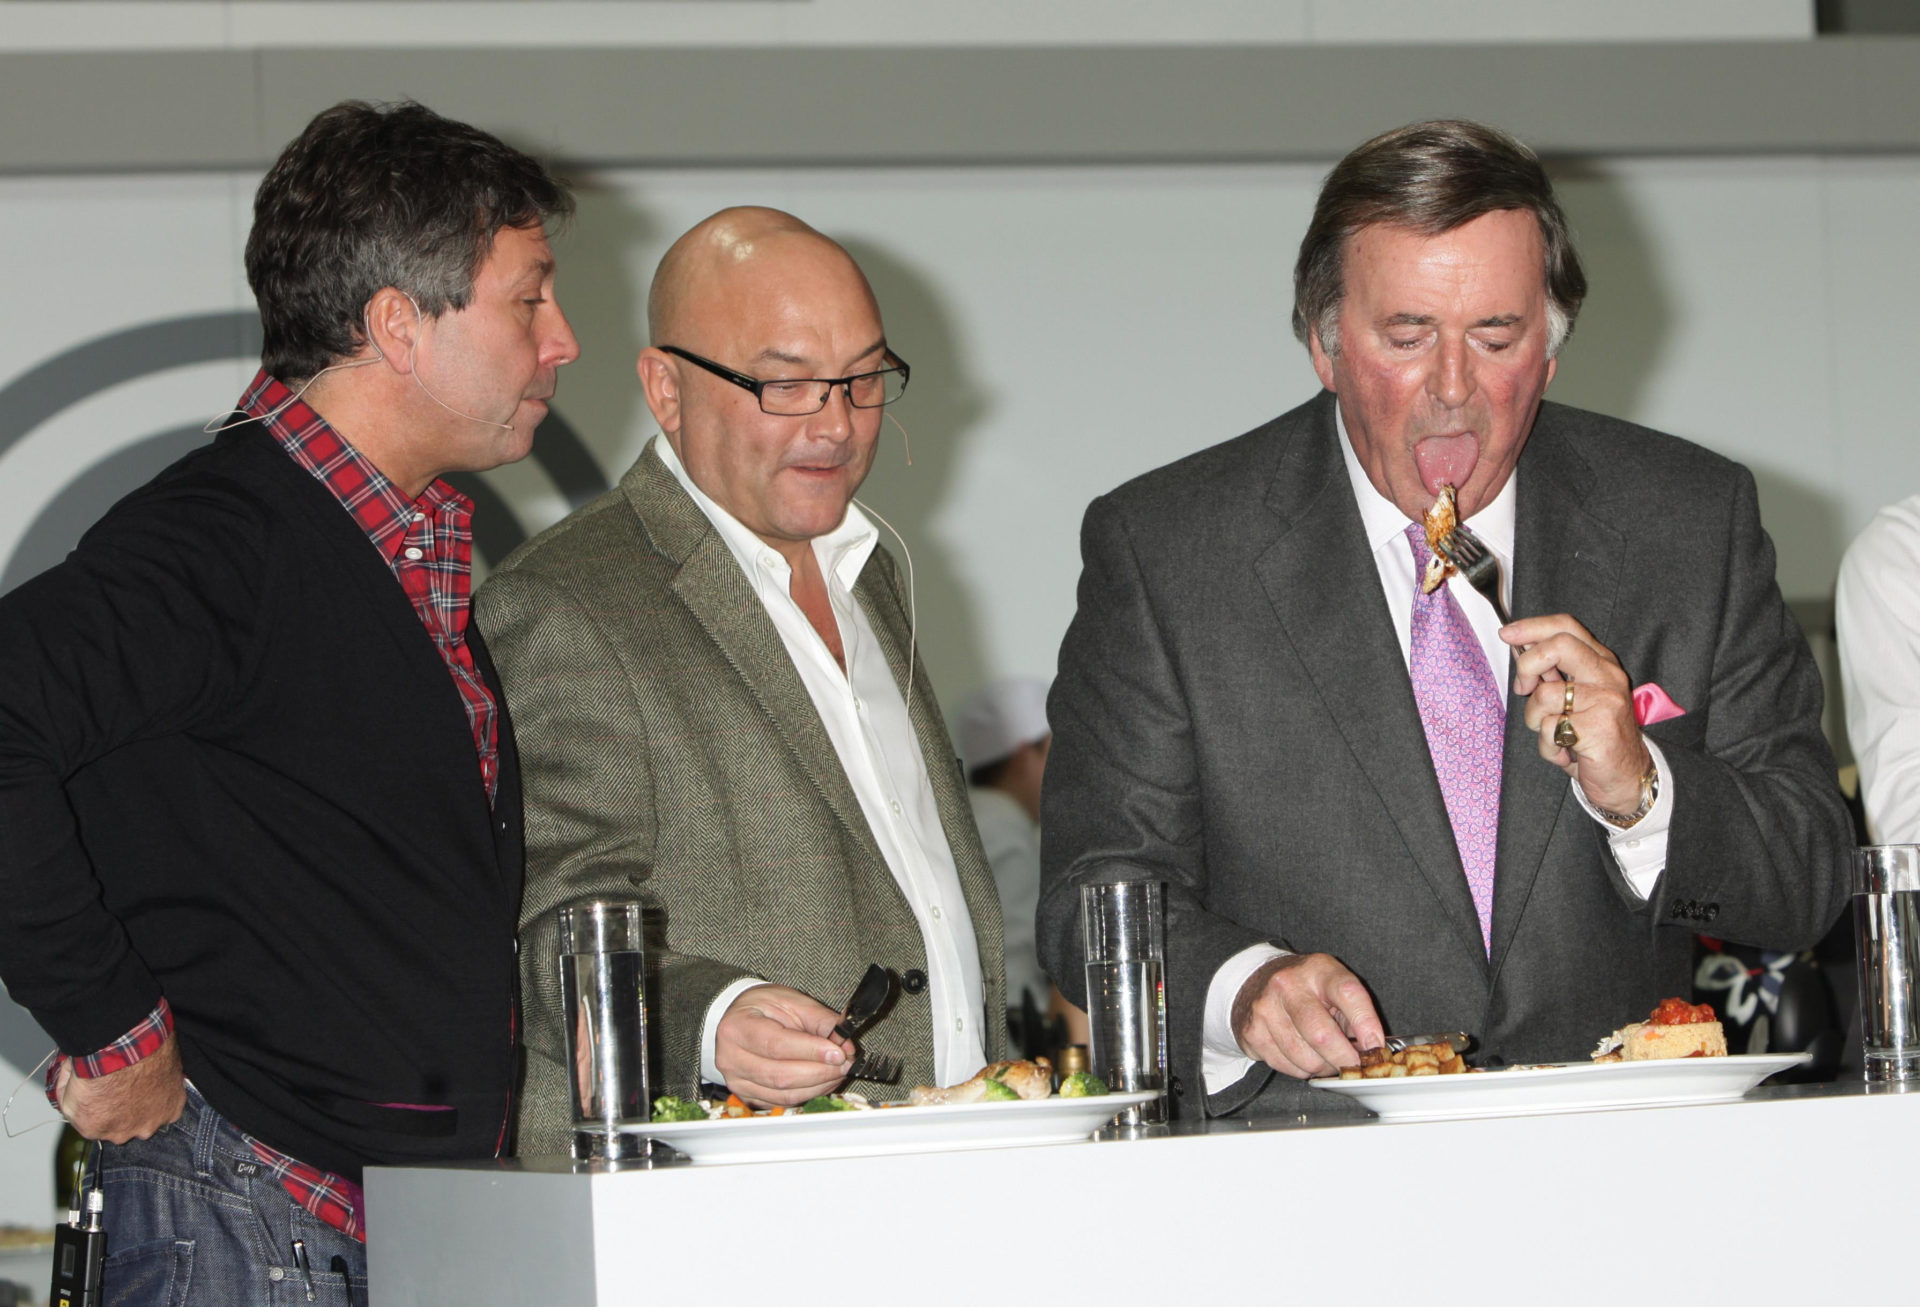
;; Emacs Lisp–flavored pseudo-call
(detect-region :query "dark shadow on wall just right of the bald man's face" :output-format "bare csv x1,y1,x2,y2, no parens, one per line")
845,240,1004,710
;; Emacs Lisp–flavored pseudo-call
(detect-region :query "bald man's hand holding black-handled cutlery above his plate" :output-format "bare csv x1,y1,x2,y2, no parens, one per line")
714,985,852,1107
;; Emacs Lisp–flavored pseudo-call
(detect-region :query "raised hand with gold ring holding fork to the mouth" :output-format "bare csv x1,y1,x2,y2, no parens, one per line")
1500,612,1653,812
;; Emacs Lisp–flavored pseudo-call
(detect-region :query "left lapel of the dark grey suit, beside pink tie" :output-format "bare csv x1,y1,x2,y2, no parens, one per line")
1254,393,1486,962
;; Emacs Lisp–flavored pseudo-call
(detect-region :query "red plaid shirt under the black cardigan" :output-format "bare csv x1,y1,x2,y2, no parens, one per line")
46,372,505,1242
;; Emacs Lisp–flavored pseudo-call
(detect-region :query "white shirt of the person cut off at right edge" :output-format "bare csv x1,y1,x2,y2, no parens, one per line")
1834,495,1920,844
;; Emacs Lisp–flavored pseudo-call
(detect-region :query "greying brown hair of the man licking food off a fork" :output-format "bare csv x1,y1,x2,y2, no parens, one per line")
1294,119,1586,359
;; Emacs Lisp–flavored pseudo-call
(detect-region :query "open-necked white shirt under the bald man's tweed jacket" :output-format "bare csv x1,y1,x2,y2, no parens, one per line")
653,436,987,1084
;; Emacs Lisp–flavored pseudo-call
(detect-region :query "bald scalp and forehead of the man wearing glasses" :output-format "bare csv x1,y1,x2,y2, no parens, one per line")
647,205,874,345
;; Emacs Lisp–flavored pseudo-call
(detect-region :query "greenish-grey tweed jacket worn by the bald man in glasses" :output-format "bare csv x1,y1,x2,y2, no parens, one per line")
474,453,1006,1153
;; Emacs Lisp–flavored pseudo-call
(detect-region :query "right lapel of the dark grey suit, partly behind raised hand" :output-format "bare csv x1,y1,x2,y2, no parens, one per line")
1492,405,1622,969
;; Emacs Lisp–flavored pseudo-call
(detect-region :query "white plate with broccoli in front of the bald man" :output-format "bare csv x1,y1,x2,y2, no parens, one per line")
626,1092,1152,1163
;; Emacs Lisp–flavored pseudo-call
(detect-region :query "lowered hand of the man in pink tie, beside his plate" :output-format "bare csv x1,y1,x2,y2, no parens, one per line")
1233,954,1386,1081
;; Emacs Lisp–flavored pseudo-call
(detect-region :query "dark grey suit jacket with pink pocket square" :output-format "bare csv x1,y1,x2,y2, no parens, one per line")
1041,393,1851,1115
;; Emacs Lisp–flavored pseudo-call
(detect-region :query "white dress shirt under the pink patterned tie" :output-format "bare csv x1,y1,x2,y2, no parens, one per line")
1200,409,1674,1094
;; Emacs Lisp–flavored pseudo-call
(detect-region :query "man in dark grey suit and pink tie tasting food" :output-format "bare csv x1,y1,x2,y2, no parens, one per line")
1041,123,1849,1117
